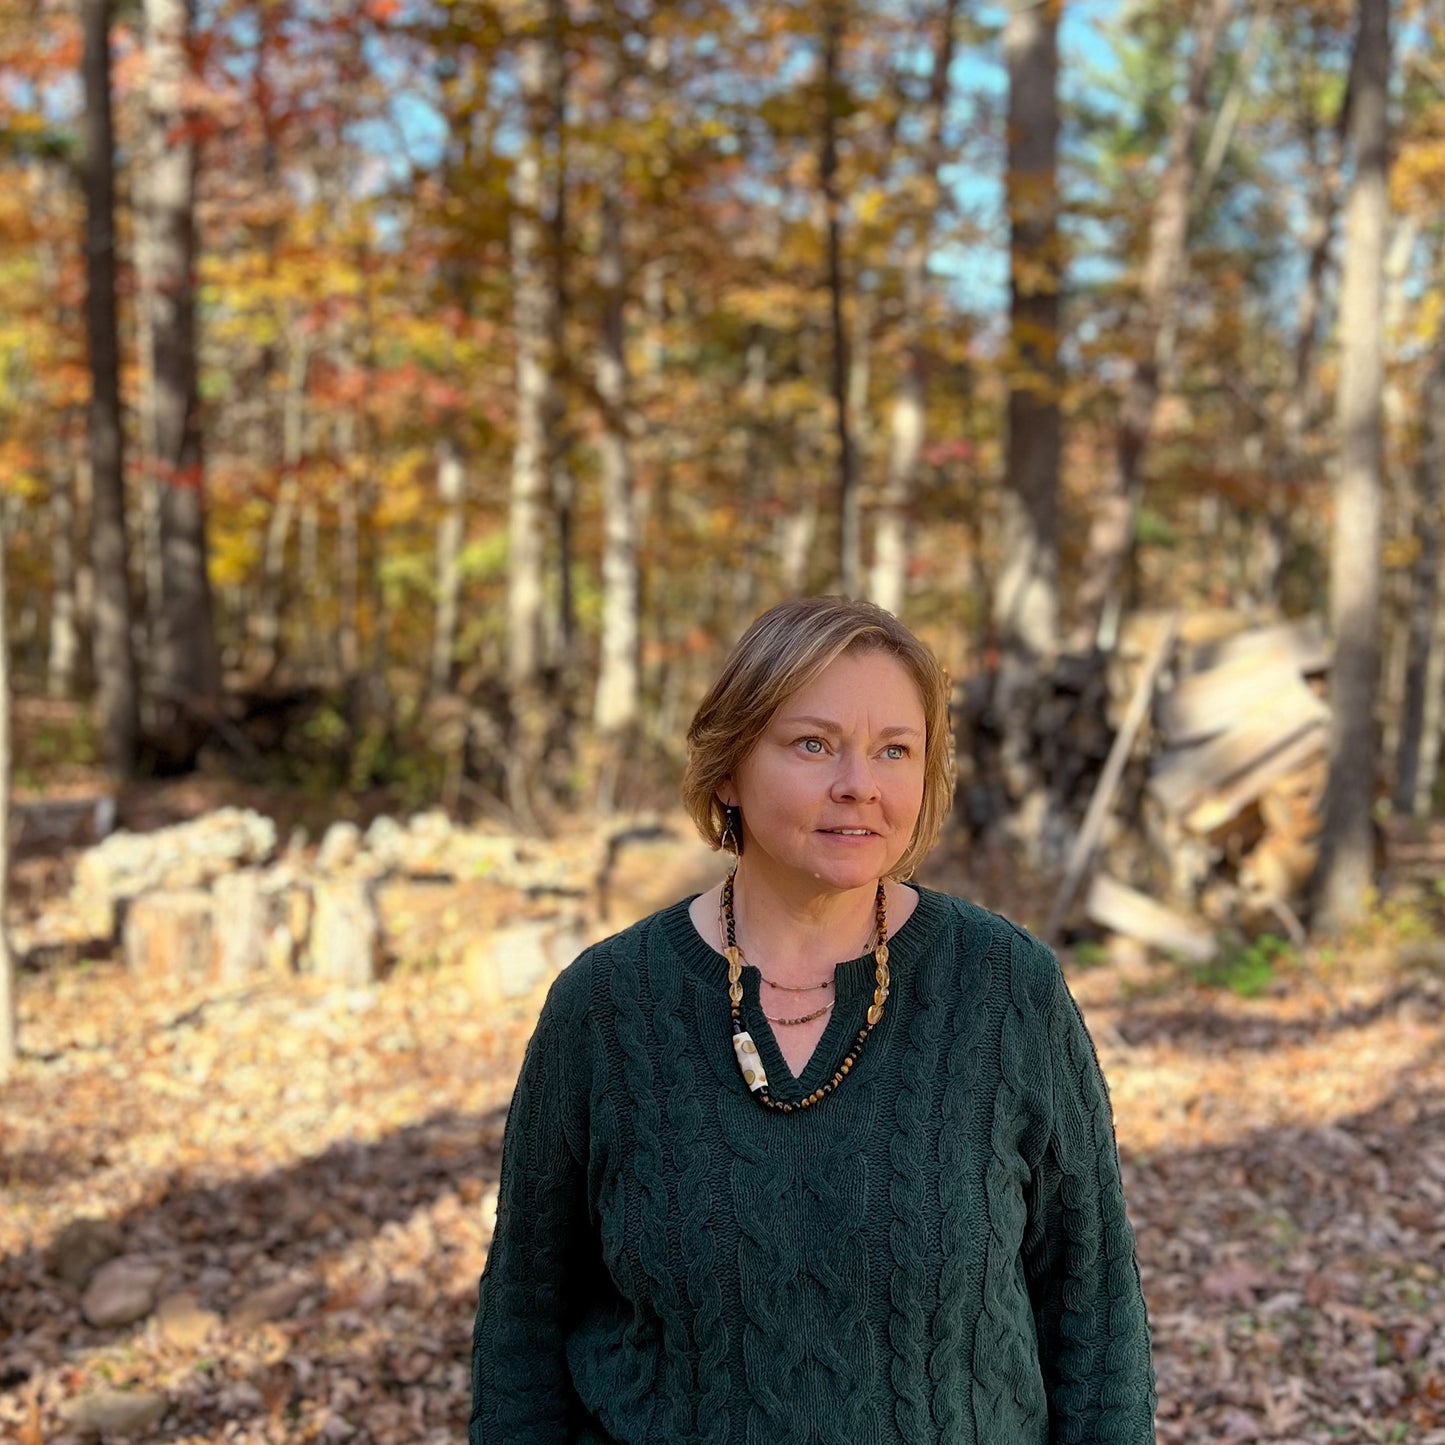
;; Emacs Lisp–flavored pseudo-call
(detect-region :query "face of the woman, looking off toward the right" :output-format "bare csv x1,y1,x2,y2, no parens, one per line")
718,652,925,893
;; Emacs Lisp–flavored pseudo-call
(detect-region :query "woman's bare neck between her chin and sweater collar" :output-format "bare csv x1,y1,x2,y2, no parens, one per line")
733,860,892,983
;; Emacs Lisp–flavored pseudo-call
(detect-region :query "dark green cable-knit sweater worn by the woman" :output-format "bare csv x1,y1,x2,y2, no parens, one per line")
468,889,1155,1445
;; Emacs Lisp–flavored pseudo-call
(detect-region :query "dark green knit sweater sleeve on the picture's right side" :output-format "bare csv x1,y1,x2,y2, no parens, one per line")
1025,961,1157,1445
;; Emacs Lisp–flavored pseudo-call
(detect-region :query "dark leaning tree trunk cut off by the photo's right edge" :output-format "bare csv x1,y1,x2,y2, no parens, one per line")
1394,338,1445,818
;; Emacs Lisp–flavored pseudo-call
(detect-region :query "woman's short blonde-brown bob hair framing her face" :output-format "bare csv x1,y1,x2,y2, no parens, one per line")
682,597,954,879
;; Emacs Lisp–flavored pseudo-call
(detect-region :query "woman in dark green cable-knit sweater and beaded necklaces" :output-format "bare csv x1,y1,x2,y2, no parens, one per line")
470,598,1155,1445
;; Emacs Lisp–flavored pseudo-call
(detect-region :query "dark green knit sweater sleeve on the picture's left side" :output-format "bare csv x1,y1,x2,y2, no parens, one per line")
467,965,588,1445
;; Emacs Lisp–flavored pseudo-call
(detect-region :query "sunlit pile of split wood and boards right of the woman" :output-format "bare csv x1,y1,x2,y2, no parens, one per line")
1085,613,1331,958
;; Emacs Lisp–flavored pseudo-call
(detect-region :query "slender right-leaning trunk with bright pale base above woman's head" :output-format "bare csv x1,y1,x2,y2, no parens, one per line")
868,0,958,614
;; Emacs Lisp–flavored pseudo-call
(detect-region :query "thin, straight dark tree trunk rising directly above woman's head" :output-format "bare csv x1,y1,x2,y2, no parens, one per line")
818,0,863,597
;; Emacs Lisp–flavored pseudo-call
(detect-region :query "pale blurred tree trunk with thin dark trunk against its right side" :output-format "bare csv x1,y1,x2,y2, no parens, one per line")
507,28,552,694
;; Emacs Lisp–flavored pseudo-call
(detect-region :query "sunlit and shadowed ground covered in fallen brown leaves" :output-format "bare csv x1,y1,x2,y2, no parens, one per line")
0,797,1445,1445
